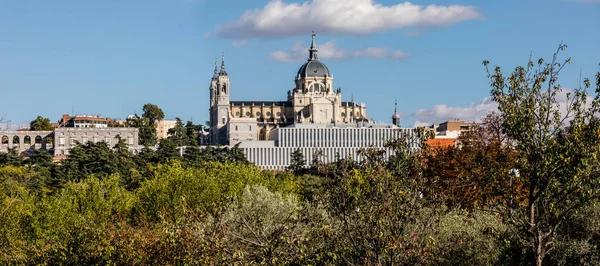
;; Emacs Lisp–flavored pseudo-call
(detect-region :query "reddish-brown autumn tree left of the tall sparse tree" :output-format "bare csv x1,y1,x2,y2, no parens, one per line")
424,113,525,209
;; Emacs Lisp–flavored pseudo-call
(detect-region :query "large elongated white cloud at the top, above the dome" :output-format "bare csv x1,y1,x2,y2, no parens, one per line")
217,0,482,38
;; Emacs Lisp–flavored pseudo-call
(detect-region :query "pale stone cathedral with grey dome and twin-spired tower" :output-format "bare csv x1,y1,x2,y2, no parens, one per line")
209,34,384,145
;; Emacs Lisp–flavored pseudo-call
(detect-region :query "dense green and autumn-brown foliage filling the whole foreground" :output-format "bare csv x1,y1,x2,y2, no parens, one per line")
0,46,600,265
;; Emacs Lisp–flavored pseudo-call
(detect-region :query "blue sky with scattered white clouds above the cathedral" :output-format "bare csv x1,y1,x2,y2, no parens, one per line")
0,0,600,127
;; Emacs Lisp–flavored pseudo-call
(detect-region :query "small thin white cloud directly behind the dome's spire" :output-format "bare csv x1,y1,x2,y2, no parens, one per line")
270,40,410,62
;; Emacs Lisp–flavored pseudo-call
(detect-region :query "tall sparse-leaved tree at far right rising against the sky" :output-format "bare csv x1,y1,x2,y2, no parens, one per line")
483,44,600,266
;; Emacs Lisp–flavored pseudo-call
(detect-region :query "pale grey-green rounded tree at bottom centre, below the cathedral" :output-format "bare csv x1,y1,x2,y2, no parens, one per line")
208,185,328,265
